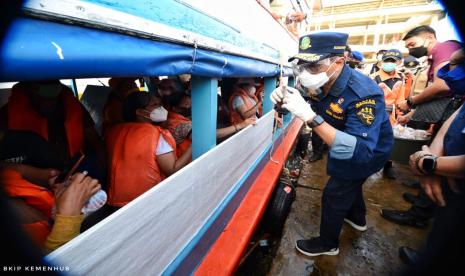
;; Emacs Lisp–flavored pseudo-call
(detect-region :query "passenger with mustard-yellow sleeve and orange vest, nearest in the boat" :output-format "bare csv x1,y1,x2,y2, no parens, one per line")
0,127,104,251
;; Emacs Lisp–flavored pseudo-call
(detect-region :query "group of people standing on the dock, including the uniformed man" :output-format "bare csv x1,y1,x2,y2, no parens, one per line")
271,26,465,275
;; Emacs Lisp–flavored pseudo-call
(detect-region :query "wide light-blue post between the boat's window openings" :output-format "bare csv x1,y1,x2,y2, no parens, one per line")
191,76,218,159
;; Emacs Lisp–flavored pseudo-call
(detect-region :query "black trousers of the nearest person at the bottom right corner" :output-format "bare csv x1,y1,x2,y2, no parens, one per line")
406,184,465,275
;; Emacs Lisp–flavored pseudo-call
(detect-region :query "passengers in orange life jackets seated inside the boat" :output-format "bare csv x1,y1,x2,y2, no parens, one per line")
0,75,264,252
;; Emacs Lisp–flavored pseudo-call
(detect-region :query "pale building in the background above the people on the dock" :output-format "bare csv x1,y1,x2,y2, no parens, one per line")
306,0,448,58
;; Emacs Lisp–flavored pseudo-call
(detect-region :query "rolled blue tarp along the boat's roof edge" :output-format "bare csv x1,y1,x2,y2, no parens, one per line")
0,18,292,82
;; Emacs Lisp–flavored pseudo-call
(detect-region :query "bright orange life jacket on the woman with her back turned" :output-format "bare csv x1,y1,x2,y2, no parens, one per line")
107,123,176,207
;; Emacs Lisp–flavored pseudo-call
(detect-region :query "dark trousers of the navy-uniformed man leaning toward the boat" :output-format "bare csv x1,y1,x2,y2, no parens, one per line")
320,177,366,247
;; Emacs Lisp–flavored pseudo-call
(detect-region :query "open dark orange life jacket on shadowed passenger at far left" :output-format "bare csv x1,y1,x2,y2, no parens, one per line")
7,83,84,156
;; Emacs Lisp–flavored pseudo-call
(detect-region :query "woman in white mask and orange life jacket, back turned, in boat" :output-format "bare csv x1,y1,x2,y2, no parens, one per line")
107,92,192,207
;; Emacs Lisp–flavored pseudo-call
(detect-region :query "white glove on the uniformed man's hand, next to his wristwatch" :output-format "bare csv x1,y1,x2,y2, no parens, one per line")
280,87,316,122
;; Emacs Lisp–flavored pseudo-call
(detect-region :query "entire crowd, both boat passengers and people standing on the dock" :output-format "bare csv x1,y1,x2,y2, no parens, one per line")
0,17,465,272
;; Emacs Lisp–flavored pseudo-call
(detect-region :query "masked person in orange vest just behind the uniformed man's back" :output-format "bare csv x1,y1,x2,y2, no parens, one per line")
370,49,405,179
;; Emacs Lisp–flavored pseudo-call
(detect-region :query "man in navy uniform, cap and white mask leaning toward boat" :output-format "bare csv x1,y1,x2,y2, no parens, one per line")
271,32,394,256
